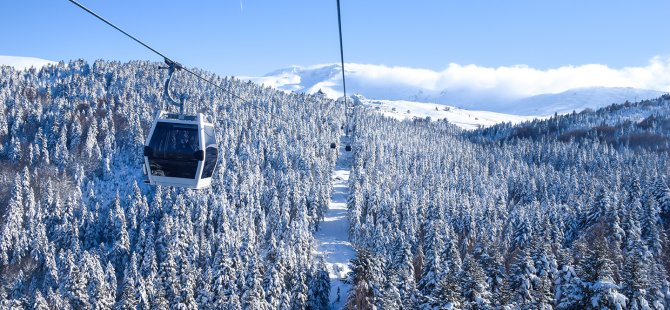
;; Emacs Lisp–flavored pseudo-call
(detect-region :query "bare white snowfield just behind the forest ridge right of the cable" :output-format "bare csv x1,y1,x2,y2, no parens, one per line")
359,99,536,129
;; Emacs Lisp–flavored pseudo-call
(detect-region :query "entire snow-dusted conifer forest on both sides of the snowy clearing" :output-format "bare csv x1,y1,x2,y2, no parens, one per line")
0,60,670,310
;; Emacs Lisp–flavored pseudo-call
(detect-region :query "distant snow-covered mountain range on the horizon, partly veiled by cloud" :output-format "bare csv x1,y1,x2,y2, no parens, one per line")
247,64,663,116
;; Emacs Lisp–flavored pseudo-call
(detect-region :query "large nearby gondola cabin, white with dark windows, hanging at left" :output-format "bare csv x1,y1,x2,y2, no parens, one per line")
144,111,219,189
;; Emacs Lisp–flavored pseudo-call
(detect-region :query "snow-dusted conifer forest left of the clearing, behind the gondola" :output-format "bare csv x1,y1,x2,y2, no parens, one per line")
0,61,343,309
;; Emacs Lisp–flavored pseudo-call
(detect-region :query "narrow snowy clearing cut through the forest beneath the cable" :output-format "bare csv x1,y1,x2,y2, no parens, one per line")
314,137,356,309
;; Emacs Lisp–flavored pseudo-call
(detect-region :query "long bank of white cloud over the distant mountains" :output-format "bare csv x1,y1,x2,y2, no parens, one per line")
344,57,670,98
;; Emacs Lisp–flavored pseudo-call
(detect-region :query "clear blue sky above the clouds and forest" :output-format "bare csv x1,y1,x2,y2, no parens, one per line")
0,0,670,76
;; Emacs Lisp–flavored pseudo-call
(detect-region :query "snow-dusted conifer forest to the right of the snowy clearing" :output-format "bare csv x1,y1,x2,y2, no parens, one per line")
348,96,670,309
